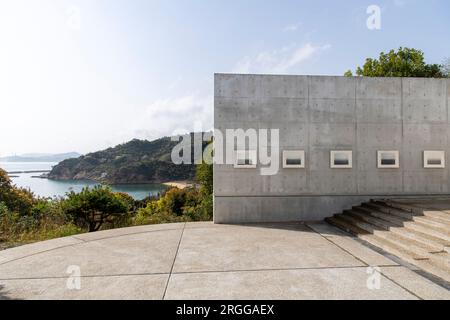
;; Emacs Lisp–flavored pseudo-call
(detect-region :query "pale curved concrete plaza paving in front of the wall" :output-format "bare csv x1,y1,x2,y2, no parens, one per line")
0,223,450,300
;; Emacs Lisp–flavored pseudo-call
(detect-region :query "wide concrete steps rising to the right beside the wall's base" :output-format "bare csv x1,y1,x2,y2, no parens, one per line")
326,200,450,283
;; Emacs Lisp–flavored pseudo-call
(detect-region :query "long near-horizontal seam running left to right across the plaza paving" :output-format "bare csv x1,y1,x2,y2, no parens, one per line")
0,265,401,281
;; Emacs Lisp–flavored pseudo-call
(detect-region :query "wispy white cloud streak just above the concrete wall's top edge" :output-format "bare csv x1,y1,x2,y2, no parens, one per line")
232,43,331,73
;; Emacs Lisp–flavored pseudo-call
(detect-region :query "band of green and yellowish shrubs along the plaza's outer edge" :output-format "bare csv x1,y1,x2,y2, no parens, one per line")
0,156,213,247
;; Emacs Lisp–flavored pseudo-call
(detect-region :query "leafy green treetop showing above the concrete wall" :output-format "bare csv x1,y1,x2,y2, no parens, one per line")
345,47,448,78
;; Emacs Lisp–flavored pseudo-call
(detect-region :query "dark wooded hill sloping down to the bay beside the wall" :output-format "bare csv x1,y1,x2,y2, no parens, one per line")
48,137,204,184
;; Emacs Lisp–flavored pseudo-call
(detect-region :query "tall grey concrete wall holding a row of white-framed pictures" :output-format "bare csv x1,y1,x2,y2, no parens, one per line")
214,74,450,223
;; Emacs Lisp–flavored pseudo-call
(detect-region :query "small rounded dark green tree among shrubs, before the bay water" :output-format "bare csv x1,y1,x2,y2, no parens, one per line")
62,186,130,232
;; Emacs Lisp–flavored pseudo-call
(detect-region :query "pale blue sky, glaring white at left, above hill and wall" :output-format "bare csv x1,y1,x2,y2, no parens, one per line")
0,0,450,156
